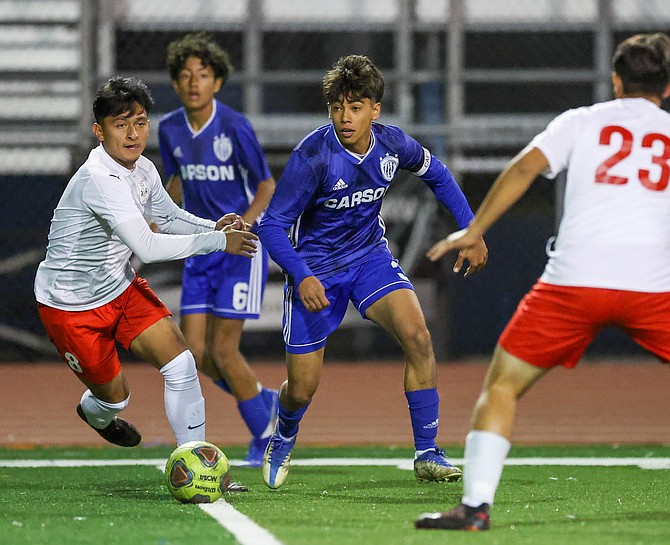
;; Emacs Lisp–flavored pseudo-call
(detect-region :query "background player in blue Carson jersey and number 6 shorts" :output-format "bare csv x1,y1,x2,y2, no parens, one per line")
158,32,277,466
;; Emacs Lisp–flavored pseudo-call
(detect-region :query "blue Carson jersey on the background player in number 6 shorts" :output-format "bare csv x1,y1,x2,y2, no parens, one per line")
158,100,272,220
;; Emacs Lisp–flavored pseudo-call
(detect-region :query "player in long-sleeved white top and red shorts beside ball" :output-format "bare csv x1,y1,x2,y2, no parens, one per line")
35,77,257,447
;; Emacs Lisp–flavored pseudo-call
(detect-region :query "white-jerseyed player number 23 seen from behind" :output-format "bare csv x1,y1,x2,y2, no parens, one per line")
415,34,670,530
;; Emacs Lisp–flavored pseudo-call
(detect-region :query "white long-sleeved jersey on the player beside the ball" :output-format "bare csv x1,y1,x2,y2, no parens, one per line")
35,145,225,311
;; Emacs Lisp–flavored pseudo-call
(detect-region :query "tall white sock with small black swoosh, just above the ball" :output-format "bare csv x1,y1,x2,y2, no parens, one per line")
161,350,205,446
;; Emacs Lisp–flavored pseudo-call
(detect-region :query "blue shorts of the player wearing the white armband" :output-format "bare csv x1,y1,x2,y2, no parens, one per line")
282,252,414,354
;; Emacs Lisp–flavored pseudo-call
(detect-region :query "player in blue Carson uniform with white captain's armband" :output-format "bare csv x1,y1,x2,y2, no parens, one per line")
258,55,487,488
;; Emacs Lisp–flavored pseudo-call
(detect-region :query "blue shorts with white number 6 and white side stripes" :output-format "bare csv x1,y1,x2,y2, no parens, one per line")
181,243,268,320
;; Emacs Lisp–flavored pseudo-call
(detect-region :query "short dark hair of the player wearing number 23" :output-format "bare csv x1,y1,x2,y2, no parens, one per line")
612,32,670,96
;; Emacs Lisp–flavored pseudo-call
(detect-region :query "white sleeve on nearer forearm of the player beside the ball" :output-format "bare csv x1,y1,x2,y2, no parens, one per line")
114,218,226,263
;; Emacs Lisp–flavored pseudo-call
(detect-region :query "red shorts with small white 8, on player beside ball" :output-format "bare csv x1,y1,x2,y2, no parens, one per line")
38,277,171,384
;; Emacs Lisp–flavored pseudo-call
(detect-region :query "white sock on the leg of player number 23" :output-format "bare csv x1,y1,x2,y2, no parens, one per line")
462,430,511,507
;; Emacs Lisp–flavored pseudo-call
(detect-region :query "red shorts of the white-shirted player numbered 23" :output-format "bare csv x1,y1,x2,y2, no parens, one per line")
498,281,670,367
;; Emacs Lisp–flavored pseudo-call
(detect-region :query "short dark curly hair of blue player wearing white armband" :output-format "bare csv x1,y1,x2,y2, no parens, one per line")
323,55,384,104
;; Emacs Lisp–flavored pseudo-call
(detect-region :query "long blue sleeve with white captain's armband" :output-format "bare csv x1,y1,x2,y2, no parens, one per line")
401,133,475,229
